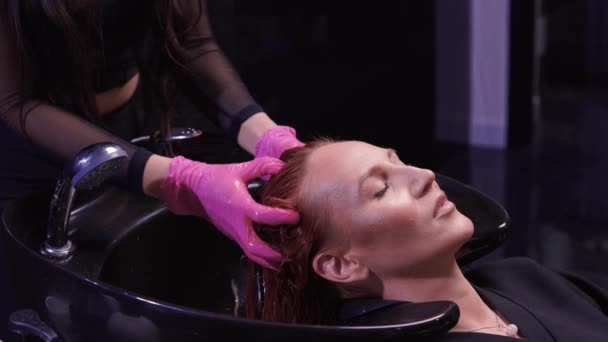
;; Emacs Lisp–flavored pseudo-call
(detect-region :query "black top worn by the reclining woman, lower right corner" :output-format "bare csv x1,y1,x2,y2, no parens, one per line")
425,258,608,342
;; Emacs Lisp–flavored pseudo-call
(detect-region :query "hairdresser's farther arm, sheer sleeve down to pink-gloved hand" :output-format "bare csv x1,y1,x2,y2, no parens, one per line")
174,0,302,158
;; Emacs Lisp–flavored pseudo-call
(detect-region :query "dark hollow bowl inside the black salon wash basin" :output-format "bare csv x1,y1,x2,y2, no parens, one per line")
99,211,247,315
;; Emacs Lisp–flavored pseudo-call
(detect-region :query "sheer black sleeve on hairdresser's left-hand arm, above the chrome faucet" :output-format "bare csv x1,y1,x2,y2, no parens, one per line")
0,18,151,192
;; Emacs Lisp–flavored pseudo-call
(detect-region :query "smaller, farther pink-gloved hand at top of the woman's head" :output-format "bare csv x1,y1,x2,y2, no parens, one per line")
255,126,304,158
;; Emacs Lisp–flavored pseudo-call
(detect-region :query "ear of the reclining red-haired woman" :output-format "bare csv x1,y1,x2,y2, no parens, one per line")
312,250,369,284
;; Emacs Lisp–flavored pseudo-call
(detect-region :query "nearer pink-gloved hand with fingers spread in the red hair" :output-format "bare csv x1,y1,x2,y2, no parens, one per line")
161,156,299,269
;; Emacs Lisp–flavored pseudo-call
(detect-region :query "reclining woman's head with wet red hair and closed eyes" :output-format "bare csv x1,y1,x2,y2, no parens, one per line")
247,140,473,323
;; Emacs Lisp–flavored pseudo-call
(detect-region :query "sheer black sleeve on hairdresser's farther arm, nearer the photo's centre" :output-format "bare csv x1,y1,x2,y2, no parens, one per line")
172,0,263,139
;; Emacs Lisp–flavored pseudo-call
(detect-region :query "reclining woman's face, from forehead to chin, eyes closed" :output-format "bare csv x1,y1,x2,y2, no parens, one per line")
304,141,473,277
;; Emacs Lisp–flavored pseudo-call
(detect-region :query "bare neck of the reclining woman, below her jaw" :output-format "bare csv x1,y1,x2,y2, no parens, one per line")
383,260,495,331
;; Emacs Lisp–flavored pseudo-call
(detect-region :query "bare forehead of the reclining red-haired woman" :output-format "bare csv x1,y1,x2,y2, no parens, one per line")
306,141,386,198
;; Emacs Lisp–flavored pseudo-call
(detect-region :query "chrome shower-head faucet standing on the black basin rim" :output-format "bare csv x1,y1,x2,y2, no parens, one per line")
41,143,128,260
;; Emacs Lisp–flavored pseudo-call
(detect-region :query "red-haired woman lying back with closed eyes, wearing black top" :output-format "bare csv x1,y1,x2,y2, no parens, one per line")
247,140,608,341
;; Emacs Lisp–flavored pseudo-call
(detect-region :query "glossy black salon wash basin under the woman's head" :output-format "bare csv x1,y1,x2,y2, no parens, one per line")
0,175,509,342
